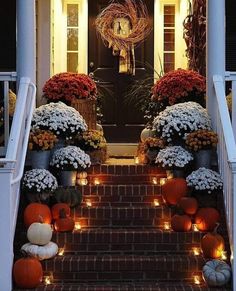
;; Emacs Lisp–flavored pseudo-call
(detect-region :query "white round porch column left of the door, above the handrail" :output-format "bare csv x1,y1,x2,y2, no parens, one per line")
16,0,36,83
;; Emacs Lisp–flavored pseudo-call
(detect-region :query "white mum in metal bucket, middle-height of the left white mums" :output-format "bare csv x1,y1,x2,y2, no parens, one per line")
50,146,91,171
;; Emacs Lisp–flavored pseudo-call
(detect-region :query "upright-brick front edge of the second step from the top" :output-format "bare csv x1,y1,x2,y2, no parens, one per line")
81,184,161,196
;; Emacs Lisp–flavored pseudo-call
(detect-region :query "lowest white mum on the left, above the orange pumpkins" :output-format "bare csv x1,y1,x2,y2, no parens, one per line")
22,169,58,193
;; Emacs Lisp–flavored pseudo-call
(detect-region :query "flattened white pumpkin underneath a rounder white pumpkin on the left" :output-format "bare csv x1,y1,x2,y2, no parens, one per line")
21,241,58,261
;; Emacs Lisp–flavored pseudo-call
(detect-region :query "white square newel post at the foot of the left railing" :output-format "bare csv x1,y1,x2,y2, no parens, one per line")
0,168,14,291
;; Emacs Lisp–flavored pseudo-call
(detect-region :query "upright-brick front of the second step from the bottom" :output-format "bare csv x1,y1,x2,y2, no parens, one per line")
42,255,205,274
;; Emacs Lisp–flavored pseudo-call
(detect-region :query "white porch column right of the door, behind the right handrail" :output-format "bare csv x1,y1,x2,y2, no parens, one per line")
206,0,225,128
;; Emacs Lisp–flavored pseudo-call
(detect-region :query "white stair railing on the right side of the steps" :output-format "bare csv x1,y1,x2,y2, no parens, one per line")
212,74,236,291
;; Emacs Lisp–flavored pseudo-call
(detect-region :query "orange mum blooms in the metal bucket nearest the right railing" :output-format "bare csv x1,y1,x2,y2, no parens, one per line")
185,130,218,152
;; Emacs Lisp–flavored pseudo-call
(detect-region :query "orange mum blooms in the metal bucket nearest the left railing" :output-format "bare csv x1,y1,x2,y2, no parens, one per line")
28,129,58,151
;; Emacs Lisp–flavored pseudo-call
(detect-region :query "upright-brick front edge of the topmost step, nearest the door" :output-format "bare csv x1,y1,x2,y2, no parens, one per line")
87,164,166,176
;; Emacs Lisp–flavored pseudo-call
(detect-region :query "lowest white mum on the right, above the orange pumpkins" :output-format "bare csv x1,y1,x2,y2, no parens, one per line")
186,168,223,194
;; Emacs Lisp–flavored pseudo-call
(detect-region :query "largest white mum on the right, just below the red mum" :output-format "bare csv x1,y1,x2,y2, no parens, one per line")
153,102,211,143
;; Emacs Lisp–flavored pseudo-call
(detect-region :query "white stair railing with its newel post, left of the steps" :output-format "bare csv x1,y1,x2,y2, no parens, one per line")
0,78,36,291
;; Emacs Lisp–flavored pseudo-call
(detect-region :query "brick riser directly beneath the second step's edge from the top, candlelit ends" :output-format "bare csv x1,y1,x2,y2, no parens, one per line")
82,193,164,206
